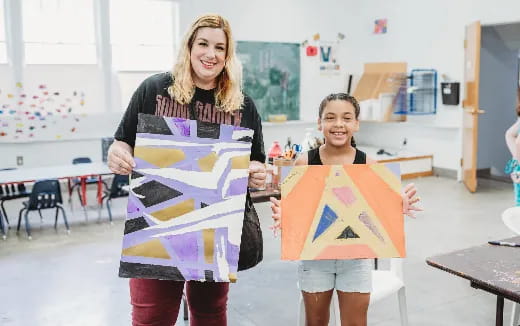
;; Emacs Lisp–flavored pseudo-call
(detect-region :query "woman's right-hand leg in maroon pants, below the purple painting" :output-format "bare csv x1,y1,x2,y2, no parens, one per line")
186,281,229,326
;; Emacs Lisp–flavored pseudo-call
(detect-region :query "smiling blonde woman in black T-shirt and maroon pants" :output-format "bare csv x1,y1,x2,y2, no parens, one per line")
108,15,265,326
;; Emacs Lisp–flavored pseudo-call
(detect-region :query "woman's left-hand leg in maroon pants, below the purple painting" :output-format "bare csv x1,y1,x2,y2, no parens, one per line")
130,278,184,326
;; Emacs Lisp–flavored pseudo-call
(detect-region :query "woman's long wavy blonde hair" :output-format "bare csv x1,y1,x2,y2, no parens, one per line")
168,14,244,112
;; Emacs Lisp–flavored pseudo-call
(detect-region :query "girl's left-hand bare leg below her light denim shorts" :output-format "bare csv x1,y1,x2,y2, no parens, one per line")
302,290,332,326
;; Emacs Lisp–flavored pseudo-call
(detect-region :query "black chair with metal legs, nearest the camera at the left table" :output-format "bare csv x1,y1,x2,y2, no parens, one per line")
16,179,70,240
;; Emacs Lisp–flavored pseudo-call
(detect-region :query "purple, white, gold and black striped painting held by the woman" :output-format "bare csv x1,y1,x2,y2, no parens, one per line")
119,114,253,282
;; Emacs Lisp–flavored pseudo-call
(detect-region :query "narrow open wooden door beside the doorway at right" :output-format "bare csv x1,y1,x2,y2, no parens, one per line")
462,21,483,192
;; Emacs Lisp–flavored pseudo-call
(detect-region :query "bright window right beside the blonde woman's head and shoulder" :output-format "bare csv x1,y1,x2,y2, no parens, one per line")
110,0,178,110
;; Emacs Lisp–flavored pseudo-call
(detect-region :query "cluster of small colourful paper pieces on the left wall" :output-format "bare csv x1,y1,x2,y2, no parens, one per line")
0,82,85,142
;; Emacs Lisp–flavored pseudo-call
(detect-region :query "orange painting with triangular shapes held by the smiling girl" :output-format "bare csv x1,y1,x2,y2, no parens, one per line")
282,163,406,260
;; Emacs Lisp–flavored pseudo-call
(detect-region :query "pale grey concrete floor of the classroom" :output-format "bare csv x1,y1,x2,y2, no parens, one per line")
0,177,513,326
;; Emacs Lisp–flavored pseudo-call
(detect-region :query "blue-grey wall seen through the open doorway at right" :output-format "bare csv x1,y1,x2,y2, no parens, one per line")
477,24,520,175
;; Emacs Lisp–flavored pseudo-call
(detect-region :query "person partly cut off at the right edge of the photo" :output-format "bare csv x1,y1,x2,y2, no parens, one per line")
505,87,520,206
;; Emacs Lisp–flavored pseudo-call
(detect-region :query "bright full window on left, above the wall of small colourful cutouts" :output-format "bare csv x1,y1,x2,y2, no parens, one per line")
22,0,96,64
